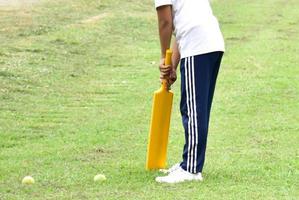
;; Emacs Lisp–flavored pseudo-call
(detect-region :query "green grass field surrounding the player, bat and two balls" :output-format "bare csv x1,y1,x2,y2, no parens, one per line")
0,0,299,200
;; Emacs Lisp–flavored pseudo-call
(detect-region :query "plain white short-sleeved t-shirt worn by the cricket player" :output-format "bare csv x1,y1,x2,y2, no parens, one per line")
155,0,225,58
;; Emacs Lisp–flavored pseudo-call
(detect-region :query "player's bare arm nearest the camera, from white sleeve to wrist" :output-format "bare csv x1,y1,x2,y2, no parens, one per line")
157,6,173,58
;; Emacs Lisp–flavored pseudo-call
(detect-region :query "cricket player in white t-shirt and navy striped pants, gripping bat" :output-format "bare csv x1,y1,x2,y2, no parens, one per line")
155,0,225,183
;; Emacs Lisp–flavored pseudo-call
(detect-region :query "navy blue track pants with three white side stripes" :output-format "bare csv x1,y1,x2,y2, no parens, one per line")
180,52,223,173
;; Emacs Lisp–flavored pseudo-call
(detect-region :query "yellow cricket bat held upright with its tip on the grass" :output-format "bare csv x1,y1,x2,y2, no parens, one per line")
146,49,173,170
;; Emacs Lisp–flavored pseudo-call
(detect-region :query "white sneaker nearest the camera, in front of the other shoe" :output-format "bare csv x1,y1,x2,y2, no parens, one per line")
156,167,203,183
